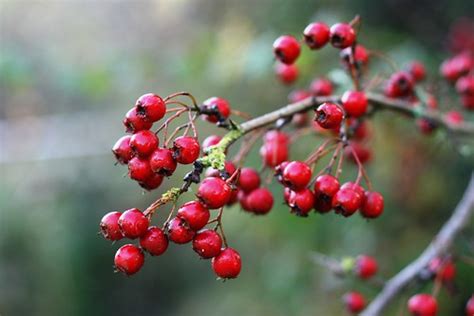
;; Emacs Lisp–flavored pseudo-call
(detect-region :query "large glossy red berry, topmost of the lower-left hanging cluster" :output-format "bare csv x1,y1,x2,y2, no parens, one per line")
196,177,232,209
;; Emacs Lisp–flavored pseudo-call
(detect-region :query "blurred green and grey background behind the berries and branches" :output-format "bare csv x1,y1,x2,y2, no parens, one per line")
0,0,474,316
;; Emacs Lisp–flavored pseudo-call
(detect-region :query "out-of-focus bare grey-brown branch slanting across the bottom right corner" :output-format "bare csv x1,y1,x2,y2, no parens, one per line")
360,173,474,316
